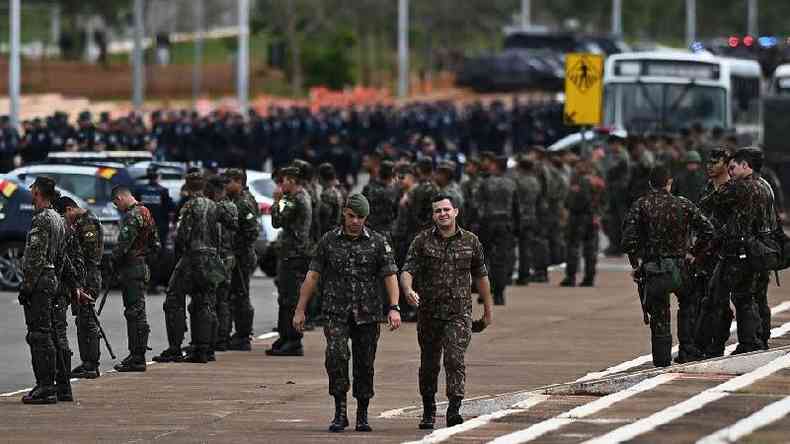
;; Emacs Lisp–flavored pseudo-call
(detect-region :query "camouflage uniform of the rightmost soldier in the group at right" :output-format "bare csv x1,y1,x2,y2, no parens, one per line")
713,174,776,353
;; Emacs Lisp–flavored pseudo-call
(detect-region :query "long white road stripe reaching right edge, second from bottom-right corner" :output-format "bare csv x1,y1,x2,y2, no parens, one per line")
584,354,790,444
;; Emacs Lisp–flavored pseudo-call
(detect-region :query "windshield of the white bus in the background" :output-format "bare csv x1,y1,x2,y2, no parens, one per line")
604,82,727,132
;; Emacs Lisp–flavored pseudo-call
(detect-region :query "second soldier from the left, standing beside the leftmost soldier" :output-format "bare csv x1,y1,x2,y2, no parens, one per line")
54,197,104,379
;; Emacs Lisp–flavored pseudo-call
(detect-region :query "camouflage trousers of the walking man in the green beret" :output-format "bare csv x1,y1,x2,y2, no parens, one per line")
324,319,380,399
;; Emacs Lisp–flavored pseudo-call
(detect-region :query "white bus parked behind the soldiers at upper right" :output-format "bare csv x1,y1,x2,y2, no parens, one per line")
603,51,762,136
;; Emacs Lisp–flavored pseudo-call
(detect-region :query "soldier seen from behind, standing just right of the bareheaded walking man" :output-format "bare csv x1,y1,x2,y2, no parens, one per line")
479,152,519,305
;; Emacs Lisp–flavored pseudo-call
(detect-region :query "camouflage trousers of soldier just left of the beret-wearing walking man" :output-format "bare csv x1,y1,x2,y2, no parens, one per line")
277,257,310,343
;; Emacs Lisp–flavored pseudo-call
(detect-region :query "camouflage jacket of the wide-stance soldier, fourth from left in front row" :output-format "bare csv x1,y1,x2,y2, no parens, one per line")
175,194,219,257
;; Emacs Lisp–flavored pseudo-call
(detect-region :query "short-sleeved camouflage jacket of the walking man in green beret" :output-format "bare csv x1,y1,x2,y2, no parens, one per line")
310,227,398,324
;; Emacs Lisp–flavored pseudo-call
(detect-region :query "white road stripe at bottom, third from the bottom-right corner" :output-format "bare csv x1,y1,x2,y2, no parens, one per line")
491,373,679,444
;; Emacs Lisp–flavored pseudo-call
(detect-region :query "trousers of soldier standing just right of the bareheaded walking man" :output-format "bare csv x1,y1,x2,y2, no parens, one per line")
480,220,516,296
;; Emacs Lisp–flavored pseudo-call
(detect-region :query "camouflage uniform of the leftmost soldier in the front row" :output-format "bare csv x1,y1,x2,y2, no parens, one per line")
20,208,68,396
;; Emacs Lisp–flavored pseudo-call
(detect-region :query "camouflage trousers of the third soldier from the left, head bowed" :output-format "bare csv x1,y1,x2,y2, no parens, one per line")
119,259,151,355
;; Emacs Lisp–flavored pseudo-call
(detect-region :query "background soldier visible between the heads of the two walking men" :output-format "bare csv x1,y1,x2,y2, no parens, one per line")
362,160,398,240
